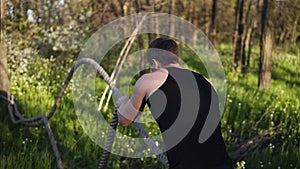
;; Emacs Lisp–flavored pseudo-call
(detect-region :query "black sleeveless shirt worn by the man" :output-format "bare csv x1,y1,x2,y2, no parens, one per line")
142,67,232,169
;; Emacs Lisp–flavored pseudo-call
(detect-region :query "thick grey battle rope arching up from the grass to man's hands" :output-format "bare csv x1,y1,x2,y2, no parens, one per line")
0,58,168,169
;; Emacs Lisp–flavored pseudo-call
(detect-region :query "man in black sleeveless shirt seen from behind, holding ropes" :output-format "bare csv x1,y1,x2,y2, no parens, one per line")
118,38,233,169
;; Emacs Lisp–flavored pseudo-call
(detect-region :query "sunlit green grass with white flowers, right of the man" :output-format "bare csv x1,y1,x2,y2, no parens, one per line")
218,44,300,169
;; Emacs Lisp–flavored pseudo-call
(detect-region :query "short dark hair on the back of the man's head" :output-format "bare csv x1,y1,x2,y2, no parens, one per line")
146,38,180,66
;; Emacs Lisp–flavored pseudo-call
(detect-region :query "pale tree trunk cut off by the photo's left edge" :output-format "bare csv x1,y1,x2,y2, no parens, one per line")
0,0,10,97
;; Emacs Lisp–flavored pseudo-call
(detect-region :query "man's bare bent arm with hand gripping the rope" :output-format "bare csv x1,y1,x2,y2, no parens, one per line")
118,76,147,126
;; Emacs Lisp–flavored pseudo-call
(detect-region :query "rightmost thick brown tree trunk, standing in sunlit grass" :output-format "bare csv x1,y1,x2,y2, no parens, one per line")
258,0,273,88
